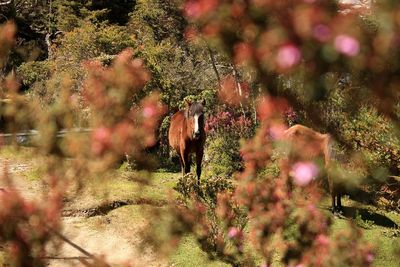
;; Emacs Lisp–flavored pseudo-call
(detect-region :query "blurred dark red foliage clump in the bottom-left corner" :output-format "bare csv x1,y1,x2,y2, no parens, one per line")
0,177,62,266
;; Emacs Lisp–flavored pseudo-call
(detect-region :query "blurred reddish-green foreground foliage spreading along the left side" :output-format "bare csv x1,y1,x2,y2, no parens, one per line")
0,18,164,266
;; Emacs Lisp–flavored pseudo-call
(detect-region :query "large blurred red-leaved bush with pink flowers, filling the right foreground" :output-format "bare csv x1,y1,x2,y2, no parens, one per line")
151,0,382,266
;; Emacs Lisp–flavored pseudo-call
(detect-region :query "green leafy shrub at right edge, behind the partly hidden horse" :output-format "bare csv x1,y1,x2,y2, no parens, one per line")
312,83,400,209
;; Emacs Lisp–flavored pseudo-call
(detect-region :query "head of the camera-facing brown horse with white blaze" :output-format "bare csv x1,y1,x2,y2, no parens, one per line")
186,101,205,140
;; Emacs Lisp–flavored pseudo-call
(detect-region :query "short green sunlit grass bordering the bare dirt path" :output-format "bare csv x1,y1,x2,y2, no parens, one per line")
0,146,400,267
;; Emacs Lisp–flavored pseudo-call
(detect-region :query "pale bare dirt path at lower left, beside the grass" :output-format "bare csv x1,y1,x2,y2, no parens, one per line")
0,158,167,267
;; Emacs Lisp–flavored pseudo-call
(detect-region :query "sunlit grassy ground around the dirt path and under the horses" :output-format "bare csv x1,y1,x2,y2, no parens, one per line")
0,148,400,267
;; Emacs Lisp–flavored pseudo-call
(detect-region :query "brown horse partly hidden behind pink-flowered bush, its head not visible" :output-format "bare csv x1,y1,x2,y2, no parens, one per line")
284,124,342,213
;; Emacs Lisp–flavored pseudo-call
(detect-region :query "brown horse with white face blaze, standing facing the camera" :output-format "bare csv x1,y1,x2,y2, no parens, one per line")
168,101,206,183
